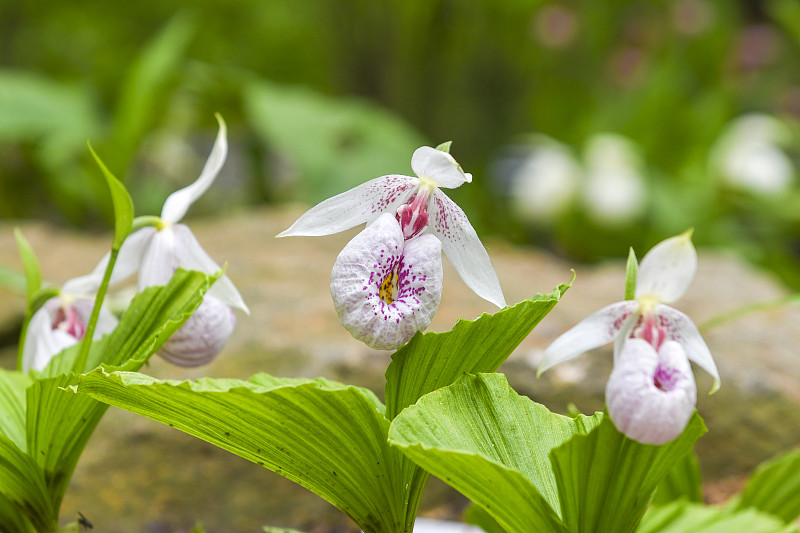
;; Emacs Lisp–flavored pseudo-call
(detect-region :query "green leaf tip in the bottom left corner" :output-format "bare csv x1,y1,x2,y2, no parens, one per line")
0,436,58,531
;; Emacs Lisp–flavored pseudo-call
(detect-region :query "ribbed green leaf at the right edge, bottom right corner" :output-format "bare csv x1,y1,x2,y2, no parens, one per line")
735,450,800,524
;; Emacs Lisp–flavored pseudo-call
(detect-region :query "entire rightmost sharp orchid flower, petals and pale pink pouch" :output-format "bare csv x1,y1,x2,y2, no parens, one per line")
538,231,720,444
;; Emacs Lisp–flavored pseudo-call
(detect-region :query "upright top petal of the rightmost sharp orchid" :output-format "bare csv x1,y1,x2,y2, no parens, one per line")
636,231,697,303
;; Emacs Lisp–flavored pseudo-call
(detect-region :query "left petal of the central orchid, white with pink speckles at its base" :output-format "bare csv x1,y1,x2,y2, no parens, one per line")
278,174,419,237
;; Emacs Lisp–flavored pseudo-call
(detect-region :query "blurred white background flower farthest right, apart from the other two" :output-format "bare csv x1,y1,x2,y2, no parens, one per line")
710,114,795,194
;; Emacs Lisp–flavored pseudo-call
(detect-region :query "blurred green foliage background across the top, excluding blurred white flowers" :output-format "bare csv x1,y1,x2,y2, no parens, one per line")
0,0,800,288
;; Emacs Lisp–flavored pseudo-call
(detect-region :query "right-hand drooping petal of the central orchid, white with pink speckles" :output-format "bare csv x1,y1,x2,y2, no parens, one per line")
428,189,506,307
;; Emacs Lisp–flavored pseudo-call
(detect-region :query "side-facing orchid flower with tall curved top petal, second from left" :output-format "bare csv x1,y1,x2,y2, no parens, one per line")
112,116,249,366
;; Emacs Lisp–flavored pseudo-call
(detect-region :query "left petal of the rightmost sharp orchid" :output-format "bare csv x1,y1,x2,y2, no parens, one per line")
536,300,639,376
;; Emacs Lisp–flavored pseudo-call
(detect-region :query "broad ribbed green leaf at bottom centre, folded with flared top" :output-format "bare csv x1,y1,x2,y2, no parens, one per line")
389,374,602,533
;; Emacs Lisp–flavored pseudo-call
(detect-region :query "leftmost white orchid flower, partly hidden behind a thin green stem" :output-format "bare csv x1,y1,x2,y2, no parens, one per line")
22,271,117,371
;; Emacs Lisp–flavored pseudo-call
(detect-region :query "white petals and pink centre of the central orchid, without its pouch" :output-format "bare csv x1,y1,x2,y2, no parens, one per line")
278,146,505,307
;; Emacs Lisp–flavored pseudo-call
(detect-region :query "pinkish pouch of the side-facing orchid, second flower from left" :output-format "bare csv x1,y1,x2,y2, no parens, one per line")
158,295,236,367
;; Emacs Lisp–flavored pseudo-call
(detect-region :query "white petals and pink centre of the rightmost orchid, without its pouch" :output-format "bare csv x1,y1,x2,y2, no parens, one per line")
538,231,719,392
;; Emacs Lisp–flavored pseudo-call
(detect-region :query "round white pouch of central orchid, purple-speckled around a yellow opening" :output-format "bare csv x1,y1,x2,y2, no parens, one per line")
331,213,442,350
